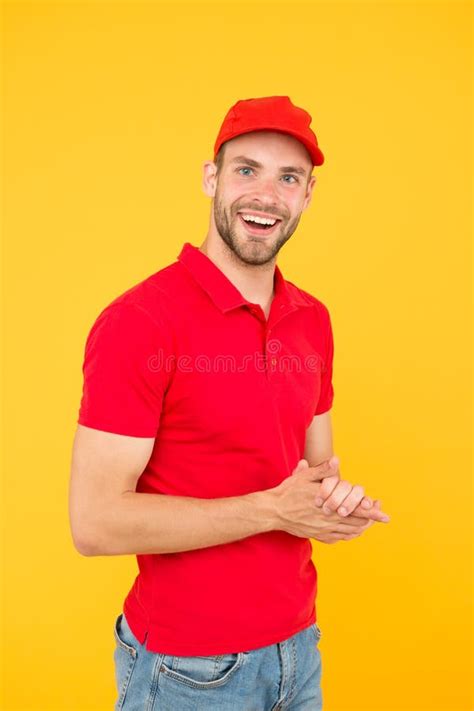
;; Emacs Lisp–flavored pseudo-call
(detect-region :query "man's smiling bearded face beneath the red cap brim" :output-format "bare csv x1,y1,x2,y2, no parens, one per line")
206,131,316,265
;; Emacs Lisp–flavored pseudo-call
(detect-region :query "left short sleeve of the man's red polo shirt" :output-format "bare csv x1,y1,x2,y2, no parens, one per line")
77,303,170,437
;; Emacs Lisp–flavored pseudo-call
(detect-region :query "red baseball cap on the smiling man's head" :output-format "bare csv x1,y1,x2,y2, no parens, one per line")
214,96,324,165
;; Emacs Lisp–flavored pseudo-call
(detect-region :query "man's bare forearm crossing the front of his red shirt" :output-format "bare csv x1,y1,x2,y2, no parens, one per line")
84,491,276,555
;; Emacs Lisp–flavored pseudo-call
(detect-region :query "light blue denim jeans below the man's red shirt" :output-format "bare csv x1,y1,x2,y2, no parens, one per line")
114,613,322,711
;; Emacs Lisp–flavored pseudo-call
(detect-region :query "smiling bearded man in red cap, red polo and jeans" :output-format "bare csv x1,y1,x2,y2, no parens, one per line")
70,96,387,711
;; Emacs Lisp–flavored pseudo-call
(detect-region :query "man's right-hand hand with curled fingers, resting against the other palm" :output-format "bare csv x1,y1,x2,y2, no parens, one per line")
312,456,390,523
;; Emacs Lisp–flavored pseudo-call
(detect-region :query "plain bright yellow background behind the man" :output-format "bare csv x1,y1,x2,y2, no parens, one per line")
2,0,472,711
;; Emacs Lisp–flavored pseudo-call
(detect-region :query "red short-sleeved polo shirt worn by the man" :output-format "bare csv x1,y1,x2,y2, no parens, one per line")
78,242,334,655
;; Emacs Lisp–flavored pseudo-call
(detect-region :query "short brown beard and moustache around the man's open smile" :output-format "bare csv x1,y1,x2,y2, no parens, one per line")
213,191,301,265
